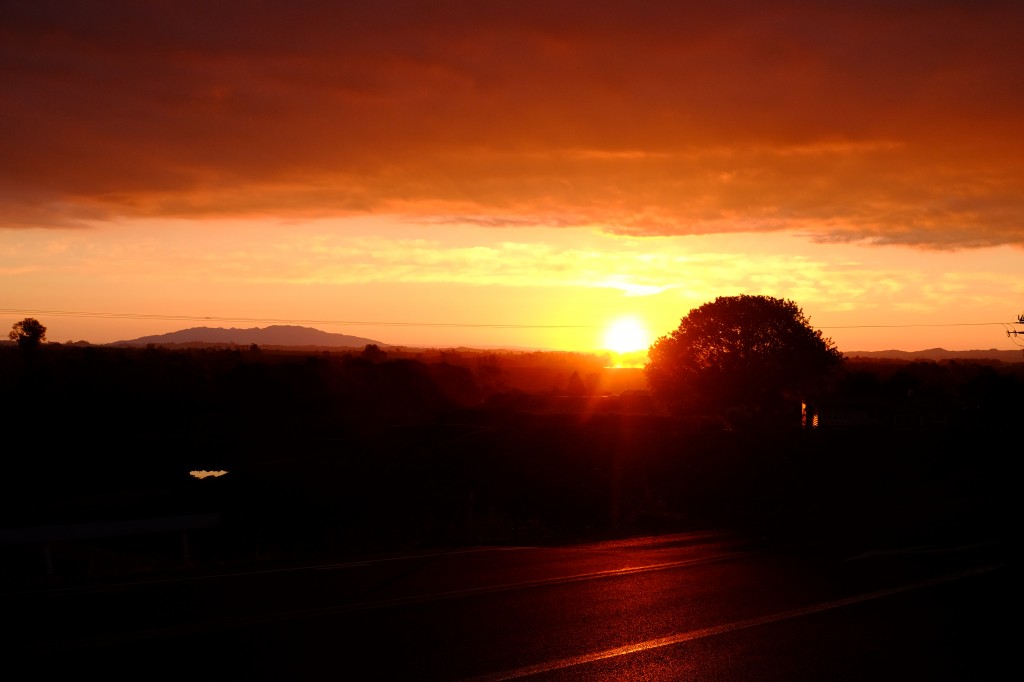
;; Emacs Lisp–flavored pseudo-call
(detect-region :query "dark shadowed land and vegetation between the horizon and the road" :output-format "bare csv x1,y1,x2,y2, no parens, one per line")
0,344,1024,582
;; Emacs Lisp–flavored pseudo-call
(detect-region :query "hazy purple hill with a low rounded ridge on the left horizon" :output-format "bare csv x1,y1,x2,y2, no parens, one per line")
110,325,388,348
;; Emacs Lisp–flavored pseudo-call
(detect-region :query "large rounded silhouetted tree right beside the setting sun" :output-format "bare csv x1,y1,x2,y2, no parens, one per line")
645,295,843,420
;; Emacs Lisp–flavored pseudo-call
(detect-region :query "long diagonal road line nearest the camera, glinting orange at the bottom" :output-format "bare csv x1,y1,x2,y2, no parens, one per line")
464,564,1004,682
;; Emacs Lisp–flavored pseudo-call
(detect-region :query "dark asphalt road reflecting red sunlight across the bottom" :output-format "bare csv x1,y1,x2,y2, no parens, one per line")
0,531,1015,681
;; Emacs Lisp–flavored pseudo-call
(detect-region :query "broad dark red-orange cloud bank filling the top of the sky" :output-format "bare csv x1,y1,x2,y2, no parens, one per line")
0,0,1024,248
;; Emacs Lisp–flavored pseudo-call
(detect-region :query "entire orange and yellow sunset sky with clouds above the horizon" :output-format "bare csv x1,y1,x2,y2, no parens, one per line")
0,0,1024,351
